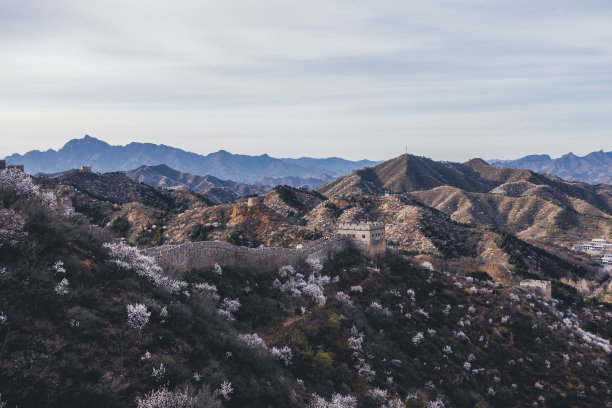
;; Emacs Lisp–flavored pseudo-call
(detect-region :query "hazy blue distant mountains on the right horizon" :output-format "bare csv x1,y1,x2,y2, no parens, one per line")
489,150,612,184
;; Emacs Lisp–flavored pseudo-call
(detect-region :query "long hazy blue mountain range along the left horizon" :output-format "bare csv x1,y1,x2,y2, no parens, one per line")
6,136,377,187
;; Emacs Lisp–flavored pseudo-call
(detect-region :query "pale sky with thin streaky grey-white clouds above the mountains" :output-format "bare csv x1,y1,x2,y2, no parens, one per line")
0,0,612,161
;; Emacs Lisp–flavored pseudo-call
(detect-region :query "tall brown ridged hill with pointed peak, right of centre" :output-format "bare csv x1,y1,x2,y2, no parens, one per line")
317,155,612,245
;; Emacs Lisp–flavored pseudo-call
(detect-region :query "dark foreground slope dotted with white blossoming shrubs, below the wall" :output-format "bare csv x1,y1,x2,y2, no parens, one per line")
0,174,612,408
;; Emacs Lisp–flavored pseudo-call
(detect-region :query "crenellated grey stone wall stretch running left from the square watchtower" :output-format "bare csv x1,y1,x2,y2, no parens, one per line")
141,235,349,271
